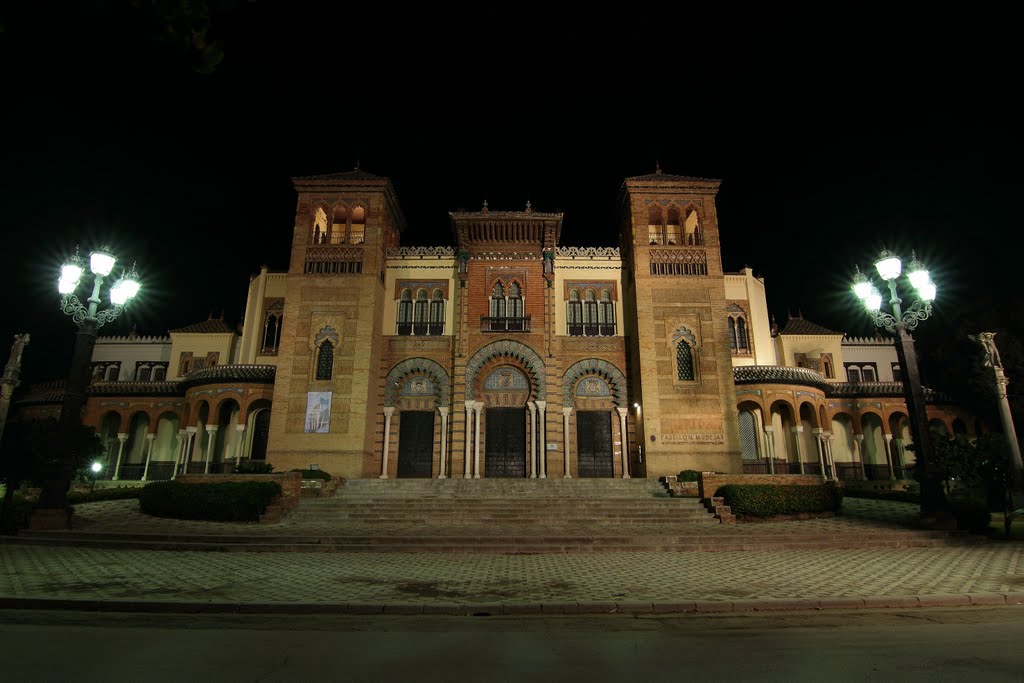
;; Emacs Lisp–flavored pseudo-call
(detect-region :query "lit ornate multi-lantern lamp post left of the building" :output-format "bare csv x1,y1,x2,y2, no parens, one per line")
30,247,140,528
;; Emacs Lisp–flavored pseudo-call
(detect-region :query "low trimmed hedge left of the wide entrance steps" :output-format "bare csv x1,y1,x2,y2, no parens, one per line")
138,481,281,521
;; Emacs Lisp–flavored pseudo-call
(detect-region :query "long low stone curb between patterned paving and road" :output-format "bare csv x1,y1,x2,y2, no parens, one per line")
0,593,1024,616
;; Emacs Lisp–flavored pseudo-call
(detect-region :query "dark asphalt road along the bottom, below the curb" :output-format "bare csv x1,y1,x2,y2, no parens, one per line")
0,606,1024,683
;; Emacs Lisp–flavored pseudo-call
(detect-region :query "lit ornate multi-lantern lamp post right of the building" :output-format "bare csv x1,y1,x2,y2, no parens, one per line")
853,250,946,524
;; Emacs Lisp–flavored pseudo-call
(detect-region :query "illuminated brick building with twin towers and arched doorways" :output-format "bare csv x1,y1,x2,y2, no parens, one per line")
20,169,974,480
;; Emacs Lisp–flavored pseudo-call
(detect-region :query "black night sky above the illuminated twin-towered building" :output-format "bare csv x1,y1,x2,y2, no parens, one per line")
0,0,1022,389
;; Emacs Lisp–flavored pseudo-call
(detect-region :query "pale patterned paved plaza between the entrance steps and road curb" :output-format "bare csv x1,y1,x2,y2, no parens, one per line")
0,499,1024,614
